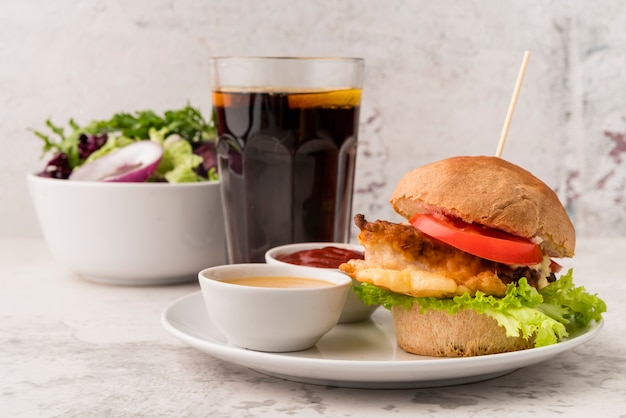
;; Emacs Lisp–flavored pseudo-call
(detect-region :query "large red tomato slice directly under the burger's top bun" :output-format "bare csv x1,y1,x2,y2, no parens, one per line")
410,214,543,266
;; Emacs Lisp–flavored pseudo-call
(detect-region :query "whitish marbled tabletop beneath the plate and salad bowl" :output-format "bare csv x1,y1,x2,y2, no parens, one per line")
0,238,626,418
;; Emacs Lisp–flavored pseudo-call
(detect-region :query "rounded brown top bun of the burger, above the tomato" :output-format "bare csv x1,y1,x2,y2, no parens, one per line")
390,156,576,257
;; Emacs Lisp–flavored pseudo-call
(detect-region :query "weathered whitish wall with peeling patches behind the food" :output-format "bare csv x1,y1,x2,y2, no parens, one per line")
0,0,626,237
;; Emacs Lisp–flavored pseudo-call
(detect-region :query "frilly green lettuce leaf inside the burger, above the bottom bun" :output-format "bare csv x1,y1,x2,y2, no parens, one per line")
354,269,606,347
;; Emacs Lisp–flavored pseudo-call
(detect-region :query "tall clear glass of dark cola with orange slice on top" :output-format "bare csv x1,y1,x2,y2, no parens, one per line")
211,57,365,263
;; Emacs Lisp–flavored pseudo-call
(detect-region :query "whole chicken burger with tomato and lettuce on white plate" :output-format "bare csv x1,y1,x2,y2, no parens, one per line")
339,156,606,357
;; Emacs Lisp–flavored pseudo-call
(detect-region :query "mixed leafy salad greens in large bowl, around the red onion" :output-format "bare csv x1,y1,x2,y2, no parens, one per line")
34,105,218,183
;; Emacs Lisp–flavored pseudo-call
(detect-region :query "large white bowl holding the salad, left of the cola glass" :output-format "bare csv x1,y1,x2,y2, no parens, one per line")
27,174,226,285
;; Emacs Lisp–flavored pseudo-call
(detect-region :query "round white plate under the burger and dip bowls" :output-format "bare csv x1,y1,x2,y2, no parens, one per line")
161,292,603,389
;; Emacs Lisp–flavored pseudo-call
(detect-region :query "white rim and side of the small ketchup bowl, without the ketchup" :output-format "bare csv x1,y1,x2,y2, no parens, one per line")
265,242,378,324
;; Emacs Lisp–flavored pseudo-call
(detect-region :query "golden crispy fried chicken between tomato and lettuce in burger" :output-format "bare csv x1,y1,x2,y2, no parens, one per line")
339,214,554,298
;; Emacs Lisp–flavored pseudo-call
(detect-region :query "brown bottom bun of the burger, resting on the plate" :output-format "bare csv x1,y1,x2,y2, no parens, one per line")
391,304,534,357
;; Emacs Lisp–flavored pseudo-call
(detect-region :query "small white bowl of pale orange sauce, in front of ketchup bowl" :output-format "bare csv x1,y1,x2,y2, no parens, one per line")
198,263,351,352
